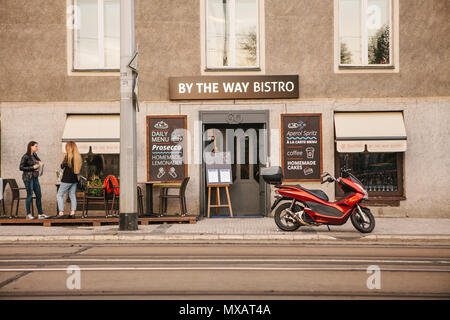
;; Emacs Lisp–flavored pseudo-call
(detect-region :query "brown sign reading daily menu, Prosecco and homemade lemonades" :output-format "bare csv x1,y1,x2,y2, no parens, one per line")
147,116,187,182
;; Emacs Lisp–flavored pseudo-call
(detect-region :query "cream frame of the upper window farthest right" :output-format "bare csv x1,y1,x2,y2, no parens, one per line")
334,0,400,73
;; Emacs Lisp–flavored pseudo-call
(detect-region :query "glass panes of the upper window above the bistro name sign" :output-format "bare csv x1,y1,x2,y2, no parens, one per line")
205,0,260,69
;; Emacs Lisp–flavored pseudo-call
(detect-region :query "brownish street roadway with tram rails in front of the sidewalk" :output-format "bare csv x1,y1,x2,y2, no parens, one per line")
0,244,450,299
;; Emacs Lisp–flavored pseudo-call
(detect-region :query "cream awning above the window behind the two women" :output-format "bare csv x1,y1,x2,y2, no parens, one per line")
62,115,120,154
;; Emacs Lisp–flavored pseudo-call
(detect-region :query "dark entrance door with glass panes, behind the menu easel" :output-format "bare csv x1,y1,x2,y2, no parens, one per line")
203,123,266,217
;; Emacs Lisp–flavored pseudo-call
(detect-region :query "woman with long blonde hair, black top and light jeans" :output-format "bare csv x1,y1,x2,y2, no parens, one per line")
56,141,83,219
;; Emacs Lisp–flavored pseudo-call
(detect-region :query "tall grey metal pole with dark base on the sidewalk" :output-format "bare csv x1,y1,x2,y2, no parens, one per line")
119,0,138,230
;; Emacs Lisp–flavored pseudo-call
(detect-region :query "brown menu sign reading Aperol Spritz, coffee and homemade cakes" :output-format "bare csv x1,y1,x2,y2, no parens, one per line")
281,114,322,181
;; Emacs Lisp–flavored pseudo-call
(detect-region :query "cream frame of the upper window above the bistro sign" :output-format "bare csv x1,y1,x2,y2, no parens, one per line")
200,0,265,75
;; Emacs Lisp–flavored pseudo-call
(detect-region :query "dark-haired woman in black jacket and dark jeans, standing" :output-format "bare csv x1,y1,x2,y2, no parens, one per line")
19,141,48,219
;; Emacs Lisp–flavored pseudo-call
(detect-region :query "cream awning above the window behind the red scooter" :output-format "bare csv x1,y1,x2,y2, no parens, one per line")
334,112,406,153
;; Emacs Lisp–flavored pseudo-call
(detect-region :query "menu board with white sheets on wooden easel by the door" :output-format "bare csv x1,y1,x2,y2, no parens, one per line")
204,152,233,186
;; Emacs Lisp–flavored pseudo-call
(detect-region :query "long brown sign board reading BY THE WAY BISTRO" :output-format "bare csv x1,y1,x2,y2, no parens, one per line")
169,75,299,100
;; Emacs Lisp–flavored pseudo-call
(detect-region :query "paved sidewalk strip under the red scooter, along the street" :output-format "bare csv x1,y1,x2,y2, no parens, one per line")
0,217,450,245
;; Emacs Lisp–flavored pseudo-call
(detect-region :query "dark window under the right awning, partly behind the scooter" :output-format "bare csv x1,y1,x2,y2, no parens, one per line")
336,152,404,205
